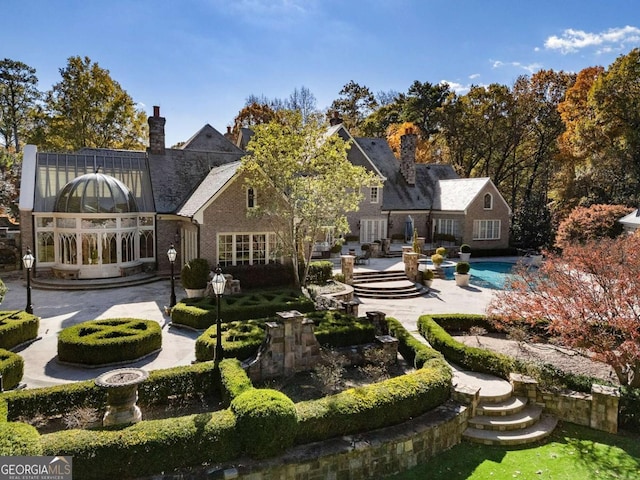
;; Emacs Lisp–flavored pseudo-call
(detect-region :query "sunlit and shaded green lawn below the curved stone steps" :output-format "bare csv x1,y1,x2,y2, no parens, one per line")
389,423,640,480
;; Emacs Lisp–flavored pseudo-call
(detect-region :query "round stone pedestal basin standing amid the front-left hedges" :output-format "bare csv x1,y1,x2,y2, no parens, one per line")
95,368,149,426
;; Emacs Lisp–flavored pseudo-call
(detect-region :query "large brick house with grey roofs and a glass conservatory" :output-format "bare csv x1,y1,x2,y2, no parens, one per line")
20,107,510,279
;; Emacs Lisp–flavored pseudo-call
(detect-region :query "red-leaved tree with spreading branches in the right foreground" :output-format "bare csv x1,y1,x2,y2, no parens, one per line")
488,235,640,388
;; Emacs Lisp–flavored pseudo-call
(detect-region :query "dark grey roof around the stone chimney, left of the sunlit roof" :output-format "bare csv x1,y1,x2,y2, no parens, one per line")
355,137,458,211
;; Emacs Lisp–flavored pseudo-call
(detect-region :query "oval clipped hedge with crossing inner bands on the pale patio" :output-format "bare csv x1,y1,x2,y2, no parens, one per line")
58,318,162,365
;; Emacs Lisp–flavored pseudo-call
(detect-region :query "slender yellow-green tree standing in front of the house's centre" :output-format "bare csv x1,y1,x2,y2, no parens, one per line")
241,111,380,285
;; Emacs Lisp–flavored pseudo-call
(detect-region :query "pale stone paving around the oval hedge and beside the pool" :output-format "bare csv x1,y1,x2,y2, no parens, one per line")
0,258,510,388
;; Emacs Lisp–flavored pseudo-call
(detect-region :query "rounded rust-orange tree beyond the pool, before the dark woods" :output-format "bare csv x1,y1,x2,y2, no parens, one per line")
556,205,632,249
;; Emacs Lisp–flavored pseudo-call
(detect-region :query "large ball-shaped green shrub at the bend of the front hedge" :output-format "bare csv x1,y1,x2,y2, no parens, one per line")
231,389,298,459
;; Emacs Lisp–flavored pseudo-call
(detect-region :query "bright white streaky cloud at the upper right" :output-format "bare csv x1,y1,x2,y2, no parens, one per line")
544,25,640,54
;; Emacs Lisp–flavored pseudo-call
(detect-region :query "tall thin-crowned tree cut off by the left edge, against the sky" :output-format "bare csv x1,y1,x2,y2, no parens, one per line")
0,58,40,153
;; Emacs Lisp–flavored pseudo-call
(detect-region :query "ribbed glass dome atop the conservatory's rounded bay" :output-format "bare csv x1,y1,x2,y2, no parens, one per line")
53,173,138,213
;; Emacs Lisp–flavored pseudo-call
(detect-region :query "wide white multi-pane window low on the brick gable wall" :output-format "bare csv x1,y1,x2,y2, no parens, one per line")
218,233,276,267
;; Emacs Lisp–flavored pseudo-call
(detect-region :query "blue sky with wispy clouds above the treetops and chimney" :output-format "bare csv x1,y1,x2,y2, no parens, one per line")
0,0,640,145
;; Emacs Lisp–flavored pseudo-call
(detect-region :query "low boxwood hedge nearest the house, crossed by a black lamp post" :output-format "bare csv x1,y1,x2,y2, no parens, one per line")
171,290,315,330
